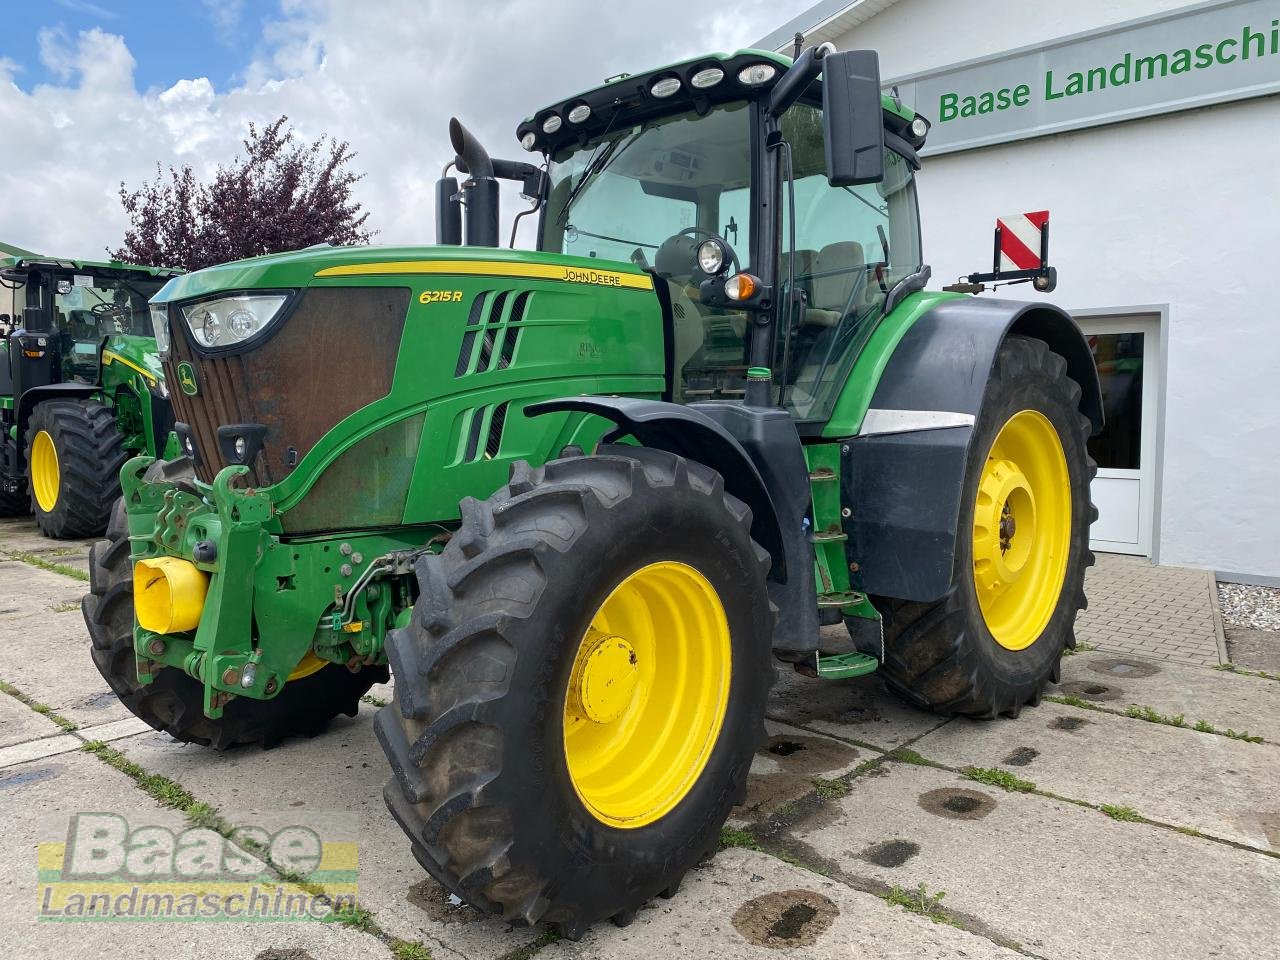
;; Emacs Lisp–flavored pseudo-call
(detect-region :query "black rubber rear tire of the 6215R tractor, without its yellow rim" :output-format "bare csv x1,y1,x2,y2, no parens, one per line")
872,337,1097,719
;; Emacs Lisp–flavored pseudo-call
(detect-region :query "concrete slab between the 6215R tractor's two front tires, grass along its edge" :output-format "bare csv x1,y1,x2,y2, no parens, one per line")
114,704,540,960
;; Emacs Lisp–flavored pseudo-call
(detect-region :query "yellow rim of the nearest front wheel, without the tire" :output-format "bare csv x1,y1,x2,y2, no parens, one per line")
564,562,731,828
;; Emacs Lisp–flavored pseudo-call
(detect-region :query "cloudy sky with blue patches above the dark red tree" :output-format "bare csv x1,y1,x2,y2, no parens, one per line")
0,0,812,259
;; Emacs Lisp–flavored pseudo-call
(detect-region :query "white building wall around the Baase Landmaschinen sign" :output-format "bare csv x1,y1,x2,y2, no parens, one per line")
837,0,1280,577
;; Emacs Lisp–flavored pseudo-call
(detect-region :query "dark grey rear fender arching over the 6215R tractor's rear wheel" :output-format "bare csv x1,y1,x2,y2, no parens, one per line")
842,298,1102,602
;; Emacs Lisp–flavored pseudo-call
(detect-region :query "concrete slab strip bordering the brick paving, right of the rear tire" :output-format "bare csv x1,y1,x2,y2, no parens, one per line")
1050,650,1280,744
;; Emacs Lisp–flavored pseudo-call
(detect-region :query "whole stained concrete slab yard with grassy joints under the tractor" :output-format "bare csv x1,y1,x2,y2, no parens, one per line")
0,522,1280,960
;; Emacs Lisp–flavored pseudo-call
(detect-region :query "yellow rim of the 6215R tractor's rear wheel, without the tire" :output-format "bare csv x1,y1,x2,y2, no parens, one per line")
973,410,1071,650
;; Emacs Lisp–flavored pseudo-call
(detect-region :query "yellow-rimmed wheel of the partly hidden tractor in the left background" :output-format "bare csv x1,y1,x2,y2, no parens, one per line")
27,401,128,540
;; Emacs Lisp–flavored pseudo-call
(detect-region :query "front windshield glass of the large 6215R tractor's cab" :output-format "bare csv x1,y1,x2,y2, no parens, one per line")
539,102,751,401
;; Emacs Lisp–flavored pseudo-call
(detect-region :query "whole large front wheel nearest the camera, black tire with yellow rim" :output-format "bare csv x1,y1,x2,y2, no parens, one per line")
375,445,773,938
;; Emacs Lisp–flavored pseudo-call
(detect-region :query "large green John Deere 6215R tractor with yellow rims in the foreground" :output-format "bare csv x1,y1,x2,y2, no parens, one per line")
84,47,1101,936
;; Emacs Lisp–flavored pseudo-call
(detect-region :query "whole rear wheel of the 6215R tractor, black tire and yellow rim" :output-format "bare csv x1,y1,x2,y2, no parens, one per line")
873,337,1097,718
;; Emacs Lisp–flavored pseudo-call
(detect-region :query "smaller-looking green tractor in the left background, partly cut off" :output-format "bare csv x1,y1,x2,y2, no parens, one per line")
0,244,178,538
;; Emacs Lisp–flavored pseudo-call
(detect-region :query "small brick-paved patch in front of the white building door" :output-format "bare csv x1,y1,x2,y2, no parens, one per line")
1075,553,1226,667
